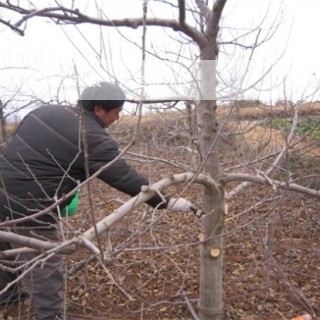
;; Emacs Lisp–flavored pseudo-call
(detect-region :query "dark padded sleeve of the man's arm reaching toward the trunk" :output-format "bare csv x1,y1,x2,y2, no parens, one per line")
89,134,168,209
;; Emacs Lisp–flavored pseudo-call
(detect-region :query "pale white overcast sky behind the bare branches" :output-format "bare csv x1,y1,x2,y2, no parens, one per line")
0,0,320,112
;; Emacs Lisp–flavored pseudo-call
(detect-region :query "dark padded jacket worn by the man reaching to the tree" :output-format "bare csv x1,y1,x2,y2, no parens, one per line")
0,105,166,226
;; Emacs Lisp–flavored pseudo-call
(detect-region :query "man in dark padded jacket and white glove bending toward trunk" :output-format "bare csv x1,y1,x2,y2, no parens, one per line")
0,82,192,320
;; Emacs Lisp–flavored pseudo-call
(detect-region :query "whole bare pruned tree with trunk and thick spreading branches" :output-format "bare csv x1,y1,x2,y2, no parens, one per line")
0,0,319,320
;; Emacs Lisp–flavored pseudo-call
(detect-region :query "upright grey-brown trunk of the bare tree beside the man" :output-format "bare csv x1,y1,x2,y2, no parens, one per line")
198,36,225,320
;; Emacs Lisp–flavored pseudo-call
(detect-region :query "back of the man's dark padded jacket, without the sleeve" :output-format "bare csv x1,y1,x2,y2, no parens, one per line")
0,105,84,225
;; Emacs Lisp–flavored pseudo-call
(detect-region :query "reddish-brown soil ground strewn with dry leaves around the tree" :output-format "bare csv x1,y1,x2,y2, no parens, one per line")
0,106,320,320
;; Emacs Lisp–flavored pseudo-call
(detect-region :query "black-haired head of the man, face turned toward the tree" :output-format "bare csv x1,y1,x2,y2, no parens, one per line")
79,82,126,127
